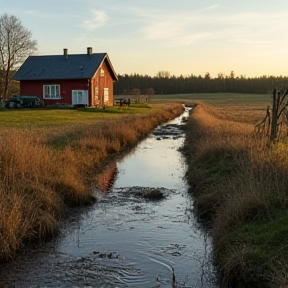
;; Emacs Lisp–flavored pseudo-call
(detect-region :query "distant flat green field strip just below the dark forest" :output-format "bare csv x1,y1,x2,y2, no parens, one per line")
151,93,272,106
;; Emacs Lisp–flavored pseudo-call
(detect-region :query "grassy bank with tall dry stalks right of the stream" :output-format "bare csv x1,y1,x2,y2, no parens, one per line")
186,105,288,287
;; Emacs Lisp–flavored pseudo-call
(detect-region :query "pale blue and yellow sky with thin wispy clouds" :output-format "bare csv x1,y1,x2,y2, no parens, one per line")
0,0,288,78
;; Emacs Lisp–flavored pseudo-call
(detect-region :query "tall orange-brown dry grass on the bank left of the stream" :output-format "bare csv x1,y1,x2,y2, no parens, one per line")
0,104,183,260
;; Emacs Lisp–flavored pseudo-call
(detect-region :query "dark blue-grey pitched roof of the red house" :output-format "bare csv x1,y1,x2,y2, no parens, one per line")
13,53,117,81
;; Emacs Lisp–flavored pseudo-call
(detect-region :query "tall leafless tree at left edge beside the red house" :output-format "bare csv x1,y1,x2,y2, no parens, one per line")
0,14,37,99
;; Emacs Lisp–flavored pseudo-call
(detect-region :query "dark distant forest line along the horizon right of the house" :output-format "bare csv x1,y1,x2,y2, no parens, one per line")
114,71,288,95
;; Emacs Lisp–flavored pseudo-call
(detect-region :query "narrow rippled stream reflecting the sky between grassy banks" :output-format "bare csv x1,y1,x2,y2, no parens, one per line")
0,112,217,288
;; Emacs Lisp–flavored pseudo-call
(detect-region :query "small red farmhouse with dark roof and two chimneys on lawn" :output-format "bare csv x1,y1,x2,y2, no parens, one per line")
13,47,118,107
